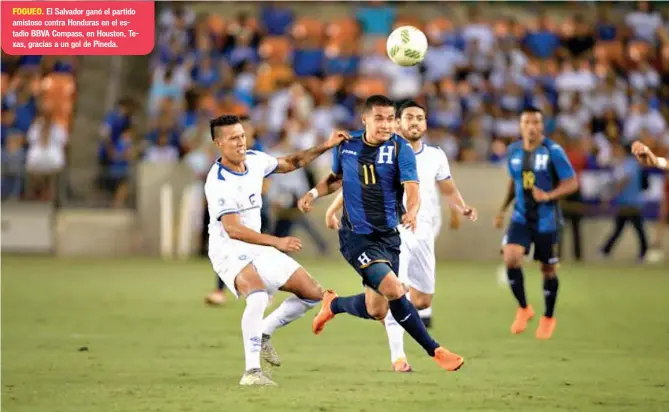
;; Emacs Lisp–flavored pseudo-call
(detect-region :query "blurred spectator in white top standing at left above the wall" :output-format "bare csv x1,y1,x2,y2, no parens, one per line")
26,111,69,201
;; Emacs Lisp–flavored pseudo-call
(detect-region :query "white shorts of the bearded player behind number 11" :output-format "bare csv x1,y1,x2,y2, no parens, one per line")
398,228,436,295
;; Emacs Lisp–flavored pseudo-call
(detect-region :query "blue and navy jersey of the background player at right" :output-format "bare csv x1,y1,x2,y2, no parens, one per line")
507,138,575,233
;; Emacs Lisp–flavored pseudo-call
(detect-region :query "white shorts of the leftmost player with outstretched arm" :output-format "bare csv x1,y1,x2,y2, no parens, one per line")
209,241,300,297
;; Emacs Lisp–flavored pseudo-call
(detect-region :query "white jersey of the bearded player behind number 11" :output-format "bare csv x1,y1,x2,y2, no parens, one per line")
404,143,451,236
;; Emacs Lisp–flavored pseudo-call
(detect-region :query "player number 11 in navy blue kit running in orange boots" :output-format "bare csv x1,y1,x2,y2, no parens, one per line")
299,95,464,371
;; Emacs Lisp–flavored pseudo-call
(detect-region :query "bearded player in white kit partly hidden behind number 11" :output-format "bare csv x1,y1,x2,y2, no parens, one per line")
325,101,477,372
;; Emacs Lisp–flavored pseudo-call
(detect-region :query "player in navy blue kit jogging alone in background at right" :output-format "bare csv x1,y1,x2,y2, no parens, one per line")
495,108,578,339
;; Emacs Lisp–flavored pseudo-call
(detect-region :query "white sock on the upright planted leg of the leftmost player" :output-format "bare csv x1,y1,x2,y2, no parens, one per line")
242,290,269,371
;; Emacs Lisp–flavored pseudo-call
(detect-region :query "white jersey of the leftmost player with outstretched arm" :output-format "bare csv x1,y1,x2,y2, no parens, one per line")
204,150,278,244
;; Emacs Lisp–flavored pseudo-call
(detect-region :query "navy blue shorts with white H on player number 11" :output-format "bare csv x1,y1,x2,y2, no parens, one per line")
339,227,401,290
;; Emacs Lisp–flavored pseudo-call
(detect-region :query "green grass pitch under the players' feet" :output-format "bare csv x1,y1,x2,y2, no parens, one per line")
2,256,669,412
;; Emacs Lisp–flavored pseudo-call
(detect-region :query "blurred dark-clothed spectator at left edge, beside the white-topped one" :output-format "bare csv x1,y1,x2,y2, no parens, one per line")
2,129,26,200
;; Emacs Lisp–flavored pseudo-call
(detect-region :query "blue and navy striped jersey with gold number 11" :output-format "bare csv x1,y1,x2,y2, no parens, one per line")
332,130,418,234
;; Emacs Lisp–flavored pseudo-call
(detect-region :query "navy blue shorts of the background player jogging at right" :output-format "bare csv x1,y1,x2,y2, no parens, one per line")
502,222,560,265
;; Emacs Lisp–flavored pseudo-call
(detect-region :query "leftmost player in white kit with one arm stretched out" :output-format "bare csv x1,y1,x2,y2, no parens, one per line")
204,115,348,385
